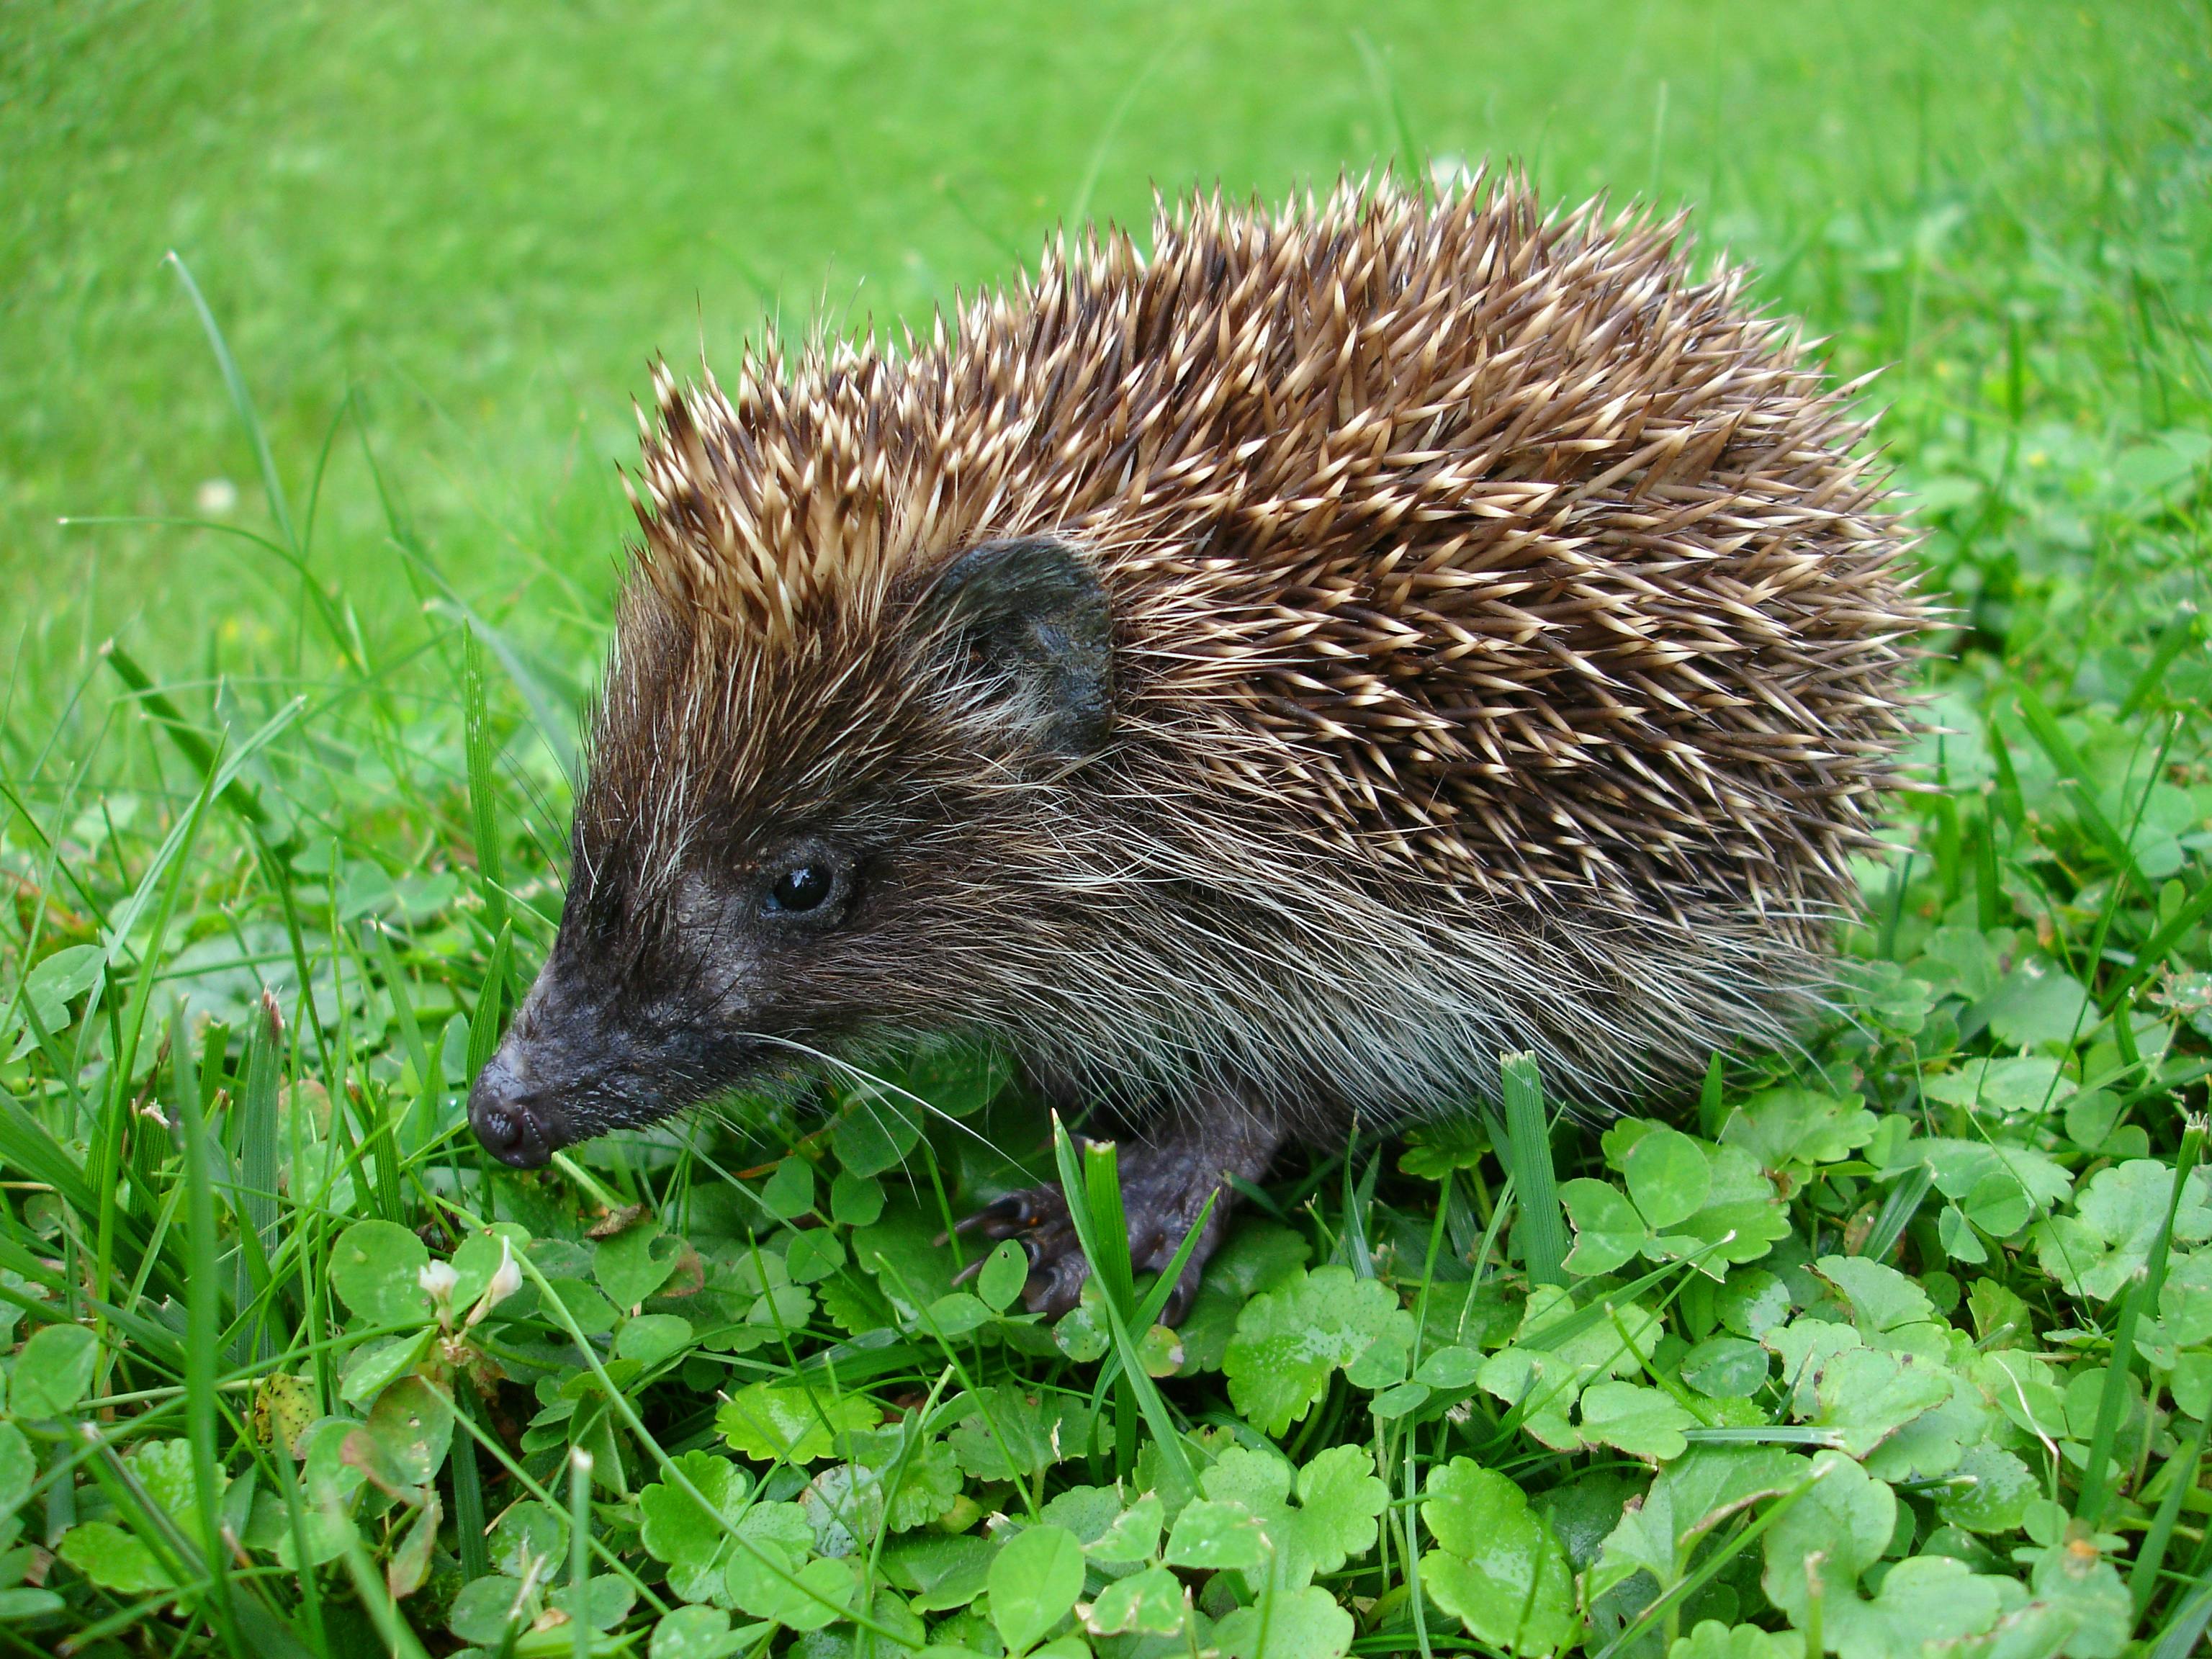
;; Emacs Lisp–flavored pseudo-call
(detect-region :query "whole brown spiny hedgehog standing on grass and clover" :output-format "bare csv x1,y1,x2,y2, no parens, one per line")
469,177,1931,1318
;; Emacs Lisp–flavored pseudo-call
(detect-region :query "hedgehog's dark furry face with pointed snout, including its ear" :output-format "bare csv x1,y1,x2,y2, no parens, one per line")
469,540,1112,1166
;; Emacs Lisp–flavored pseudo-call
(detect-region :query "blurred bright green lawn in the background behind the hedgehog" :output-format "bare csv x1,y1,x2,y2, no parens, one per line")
0,0,2206,683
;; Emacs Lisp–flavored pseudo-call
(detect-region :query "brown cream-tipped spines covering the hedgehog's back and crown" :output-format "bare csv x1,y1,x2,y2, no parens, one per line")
617,168,1927,1066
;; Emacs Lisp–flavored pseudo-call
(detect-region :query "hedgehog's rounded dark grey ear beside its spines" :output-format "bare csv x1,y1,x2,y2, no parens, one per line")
918,535,1112,761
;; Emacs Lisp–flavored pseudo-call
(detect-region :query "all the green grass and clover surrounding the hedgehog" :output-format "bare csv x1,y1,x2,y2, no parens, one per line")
0,0,2212,1659
